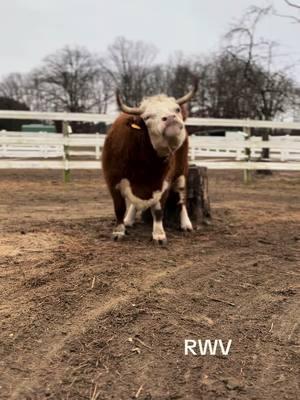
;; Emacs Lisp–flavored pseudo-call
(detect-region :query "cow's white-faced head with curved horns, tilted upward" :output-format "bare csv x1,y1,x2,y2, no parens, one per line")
117,81,197,157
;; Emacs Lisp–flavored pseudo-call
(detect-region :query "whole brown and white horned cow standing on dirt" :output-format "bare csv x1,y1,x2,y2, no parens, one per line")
102,82,197,244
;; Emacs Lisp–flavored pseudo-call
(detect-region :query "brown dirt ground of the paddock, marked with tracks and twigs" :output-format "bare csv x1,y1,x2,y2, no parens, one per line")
0,170,300,400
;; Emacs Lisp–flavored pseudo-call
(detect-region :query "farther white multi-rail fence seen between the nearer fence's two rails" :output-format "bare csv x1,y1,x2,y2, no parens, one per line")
0,132,300,161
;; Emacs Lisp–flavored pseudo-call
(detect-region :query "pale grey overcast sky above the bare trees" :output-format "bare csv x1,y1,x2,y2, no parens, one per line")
0,0,300,81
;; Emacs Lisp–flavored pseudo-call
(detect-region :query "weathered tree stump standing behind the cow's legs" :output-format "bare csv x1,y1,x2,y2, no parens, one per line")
142,165,211,228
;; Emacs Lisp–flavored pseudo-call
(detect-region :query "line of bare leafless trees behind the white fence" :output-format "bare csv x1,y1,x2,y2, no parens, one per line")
0,7,300,120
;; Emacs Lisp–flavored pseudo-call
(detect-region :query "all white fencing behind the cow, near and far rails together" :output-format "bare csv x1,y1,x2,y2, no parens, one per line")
0,111,300,171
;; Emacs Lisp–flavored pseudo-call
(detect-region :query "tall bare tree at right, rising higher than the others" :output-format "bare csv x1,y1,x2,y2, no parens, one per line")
225,6,293,119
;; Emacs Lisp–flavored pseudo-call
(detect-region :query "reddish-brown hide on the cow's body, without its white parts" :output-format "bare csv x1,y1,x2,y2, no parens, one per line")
102,114,188,199
